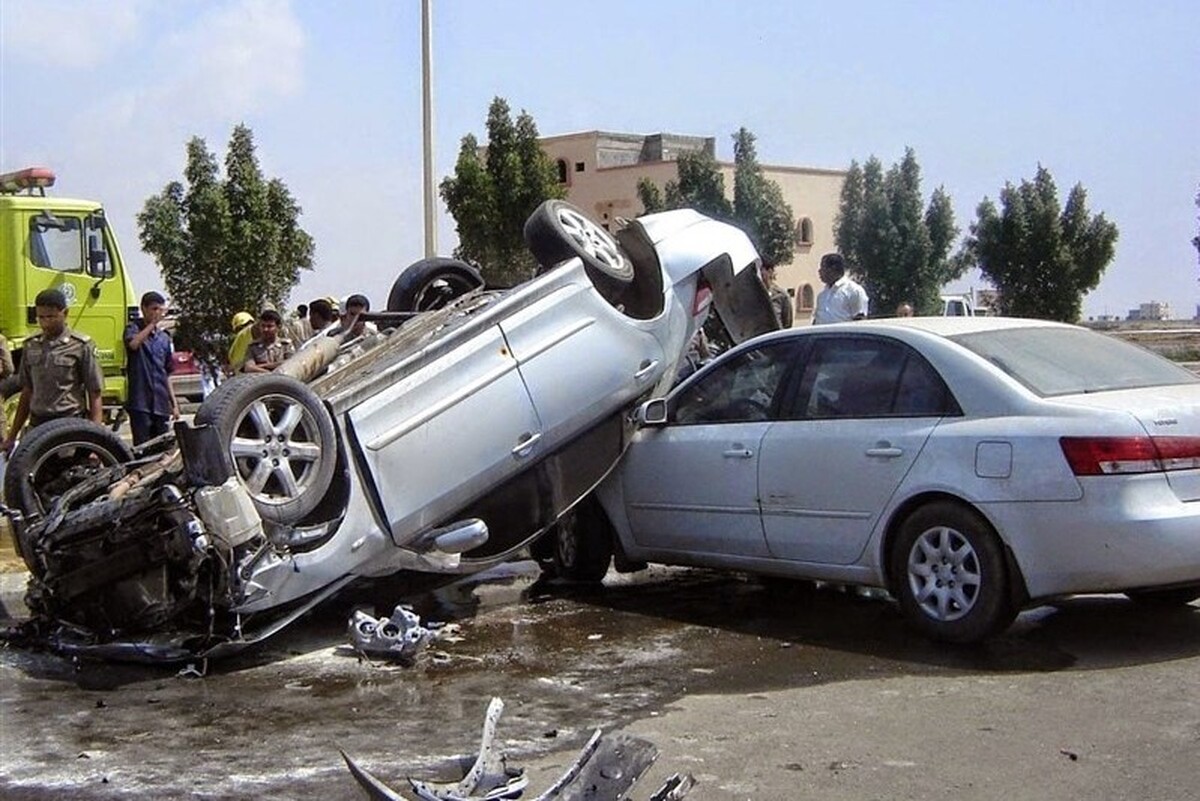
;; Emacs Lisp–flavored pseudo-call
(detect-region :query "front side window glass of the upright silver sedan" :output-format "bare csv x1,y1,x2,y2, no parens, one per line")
672,342,798,424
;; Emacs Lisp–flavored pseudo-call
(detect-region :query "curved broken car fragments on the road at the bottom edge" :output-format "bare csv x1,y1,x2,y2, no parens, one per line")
341,698,696,801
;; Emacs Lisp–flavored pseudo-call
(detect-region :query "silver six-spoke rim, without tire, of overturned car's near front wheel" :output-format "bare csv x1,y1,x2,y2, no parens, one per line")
229,395,324,504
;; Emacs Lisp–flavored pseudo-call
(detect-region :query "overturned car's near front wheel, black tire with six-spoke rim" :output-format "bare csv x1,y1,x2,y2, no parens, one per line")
196,374,337,525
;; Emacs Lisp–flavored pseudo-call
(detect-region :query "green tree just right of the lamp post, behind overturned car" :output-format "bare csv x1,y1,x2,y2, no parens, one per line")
440,97,566,287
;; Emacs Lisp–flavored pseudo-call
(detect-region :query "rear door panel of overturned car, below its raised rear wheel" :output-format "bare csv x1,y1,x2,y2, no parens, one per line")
500,276,666,450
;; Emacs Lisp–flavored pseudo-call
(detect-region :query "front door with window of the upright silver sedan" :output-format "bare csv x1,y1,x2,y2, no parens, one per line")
620,341,797,556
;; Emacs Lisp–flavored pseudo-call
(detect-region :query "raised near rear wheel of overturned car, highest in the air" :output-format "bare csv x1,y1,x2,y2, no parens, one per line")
524,200,634,297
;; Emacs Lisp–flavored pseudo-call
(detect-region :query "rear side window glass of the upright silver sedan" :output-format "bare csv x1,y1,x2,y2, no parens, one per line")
791,337,956,418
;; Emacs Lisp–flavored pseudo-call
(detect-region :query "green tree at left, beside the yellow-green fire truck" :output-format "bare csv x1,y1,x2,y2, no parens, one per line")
137,125,313,361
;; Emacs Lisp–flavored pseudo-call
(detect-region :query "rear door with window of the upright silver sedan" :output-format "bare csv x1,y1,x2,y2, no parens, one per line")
758,336,953,565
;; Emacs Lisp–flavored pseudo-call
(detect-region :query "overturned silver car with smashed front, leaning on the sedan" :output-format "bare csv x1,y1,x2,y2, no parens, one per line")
0,200,775,660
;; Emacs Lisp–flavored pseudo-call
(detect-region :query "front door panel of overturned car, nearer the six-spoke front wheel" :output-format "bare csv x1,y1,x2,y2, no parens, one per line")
349,326,541,537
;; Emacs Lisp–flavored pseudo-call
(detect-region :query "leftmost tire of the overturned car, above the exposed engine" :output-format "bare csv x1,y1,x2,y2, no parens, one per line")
4,417,133,517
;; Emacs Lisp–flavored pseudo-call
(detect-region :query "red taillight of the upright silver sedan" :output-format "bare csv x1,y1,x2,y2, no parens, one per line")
1058,436,1200,476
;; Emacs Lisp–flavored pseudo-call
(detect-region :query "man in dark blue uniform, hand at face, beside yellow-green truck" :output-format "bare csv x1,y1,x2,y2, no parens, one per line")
125,291,179,445
